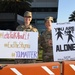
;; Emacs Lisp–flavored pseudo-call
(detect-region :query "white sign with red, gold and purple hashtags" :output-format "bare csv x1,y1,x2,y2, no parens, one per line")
0,31,38,59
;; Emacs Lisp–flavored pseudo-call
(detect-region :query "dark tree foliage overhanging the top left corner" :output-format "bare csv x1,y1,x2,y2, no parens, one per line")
0,0,32,15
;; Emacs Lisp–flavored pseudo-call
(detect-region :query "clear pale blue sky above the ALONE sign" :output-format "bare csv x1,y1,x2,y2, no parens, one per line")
57,0,75,23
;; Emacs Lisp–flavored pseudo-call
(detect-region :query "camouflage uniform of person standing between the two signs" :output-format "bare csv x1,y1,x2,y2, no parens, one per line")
40,30,53,62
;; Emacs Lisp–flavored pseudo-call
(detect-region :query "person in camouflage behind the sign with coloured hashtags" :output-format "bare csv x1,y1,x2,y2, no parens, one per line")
15,11,38,63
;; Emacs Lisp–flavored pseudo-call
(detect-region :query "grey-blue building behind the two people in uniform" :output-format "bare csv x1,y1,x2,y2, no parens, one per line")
0,0,58,32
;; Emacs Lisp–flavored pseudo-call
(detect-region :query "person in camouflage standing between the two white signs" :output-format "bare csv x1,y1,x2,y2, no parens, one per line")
40,17,53,62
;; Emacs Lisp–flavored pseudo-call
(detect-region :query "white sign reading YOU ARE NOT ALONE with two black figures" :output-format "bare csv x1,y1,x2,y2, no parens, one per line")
52,22,75,61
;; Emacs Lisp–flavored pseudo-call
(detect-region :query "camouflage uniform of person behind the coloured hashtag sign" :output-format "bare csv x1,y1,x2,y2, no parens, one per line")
15,25,38,63
